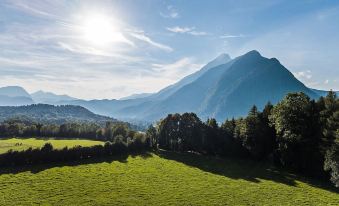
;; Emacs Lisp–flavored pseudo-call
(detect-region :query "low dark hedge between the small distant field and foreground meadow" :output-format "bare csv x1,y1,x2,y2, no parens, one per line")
0,136,150,167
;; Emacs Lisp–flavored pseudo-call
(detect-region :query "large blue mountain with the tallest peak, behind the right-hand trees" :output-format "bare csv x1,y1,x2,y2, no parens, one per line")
102,51,319,121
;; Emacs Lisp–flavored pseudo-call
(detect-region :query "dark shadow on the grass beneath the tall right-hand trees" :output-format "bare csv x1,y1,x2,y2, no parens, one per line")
157,150,339,193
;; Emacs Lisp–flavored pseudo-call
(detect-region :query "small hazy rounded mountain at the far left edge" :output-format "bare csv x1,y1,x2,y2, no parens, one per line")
0,86,34,106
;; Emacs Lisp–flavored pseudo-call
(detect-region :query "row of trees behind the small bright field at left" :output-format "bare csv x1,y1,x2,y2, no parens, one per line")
0,119,140,142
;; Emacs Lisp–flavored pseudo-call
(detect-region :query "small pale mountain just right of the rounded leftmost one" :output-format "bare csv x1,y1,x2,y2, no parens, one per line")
31,90,77,104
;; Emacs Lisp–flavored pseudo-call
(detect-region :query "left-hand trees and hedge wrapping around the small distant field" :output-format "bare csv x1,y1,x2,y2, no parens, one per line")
0,119,151,166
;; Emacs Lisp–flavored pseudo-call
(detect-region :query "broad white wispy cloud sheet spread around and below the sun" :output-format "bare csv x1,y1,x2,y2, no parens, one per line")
0,0,181,99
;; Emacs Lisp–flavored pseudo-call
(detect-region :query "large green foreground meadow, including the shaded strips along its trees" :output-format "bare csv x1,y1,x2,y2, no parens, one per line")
0,152,339,205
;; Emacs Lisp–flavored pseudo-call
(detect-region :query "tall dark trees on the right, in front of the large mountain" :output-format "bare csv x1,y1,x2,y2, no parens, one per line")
146,91,339,187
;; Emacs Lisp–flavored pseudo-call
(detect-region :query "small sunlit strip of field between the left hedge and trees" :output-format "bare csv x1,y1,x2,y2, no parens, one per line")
0,138,103,154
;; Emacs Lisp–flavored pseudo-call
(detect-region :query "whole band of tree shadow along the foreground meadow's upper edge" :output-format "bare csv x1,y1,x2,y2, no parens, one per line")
0,150,339,193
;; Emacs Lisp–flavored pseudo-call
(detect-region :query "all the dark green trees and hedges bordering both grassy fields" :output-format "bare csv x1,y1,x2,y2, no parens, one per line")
0,92,339,187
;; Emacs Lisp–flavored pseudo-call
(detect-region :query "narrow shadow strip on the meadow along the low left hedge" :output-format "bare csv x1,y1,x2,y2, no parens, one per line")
0,152,152,175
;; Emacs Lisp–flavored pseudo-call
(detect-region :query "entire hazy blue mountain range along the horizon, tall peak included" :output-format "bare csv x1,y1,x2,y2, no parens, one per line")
0,51,338,121
